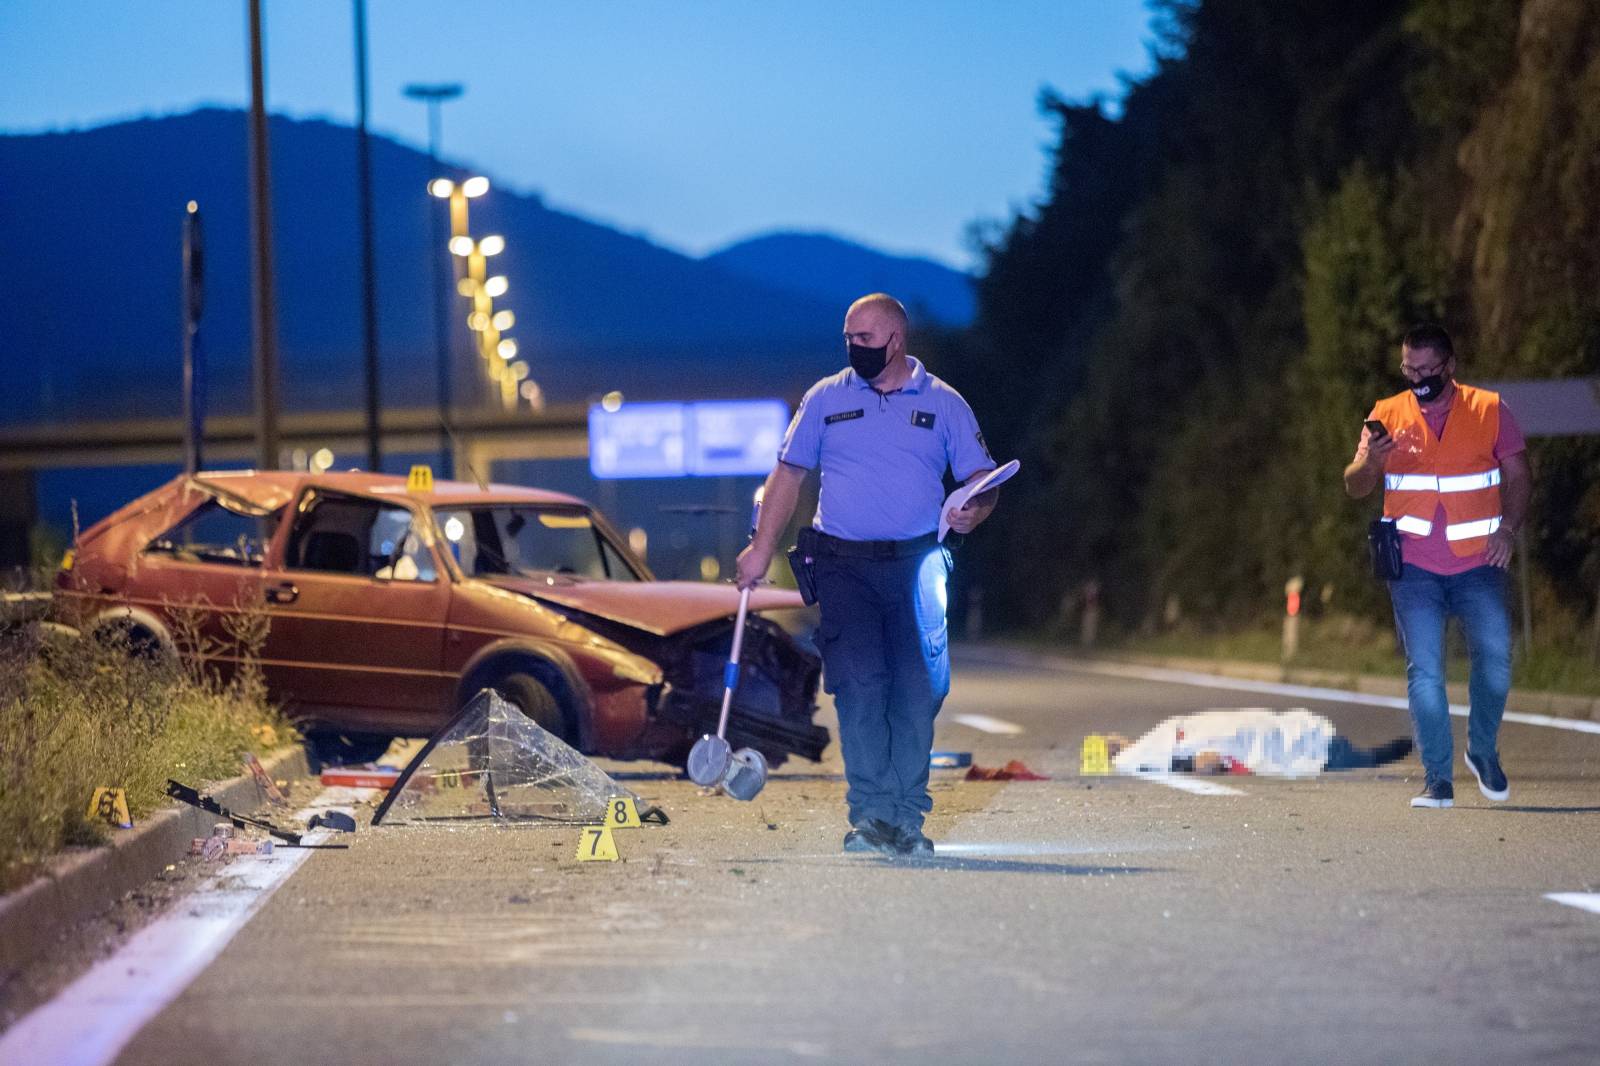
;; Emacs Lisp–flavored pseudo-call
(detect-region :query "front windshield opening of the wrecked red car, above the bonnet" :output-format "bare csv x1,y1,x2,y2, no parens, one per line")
435,504,638,581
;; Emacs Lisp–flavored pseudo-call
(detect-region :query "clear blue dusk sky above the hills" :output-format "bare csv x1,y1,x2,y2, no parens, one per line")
0,0,1152,267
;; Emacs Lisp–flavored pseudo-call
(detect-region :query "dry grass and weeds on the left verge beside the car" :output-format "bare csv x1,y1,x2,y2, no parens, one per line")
0,601,293,892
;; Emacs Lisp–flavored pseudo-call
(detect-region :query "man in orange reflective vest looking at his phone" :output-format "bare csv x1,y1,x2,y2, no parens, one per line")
1344,325,1533,808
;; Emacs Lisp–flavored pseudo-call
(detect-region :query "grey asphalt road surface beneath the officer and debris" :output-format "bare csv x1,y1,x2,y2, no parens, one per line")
46,643,1600,1066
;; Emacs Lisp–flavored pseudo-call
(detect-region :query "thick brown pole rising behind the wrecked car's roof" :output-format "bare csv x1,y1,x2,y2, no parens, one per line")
250,0,278,471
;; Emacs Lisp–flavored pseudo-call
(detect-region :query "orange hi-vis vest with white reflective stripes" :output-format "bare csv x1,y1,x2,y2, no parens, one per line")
1376,384,1501,555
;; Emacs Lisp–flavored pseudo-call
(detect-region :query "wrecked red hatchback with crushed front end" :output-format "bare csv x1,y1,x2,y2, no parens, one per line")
54,471,827,763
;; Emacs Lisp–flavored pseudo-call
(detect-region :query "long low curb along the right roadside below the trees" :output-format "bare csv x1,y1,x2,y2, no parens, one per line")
958,643,1600,722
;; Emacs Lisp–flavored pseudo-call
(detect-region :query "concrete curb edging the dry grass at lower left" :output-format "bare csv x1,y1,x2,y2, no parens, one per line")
0,744,307,976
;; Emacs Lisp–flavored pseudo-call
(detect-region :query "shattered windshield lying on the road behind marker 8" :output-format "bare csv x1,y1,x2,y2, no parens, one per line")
373,688,666,826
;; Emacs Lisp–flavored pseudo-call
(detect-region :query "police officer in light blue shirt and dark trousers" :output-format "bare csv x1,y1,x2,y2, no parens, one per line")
738,293,998,856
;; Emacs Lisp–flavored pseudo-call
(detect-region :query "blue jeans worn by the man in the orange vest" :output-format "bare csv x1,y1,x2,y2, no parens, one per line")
1389,563,1510,781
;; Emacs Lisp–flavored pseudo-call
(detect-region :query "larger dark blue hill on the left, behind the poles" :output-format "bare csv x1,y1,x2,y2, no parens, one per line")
0,109,842,423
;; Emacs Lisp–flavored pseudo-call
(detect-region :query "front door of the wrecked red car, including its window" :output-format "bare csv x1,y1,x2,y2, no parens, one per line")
264,487,454,733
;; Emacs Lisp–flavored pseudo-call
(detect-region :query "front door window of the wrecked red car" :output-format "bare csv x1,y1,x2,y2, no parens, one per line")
288,493,438,581
